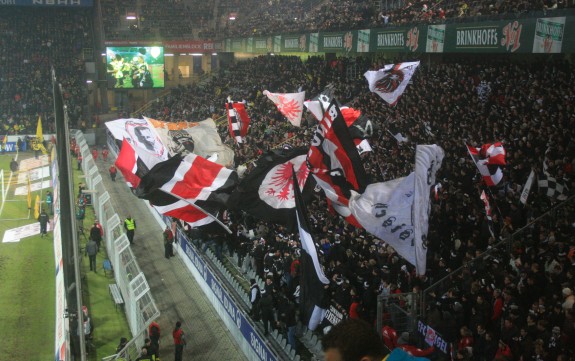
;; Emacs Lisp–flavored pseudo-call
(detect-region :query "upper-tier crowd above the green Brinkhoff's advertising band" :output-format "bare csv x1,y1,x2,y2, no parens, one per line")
95,0,575,40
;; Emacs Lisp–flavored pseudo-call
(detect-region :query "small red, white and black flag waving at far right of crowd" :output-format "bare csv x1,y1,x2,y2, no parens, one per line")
466,142,506,187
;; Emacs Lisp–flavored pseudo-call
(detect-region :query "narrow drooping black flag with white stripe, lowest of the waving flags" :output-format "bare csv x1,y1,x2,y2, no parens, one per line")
293,165,329,331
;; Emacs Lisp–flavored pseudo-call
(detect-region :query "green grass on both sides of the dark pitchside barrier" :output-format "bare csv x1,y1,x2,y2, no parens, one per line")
0,153,130,361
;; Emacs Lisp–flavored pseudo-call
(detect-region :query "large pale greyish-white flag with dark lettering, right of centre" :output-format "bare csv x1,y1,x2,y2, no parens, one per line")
349,145,444,275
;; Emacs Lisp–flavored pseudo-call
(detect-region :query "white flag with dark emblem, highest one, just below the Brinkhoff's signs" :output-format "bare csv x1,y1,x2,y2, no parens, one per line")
363,61,419,105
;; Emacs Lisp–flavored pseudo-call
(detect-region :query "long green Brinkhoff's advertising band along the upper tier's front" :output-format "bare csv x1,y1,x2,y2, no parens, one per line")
224,16,575,54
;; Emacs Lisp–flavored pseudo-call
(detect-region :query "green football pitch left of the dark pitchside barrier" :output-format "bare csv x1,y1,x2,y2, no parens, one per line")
0,153,56,361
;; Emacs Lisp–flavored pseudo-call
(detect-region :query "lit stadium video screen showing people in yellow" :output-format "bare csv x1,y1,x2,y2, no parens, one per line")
106,46,164,89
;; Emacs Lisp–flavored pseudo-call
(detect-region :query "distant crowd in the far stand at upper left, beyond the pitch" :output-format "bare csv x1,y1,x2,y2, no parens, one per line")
0,8,93,135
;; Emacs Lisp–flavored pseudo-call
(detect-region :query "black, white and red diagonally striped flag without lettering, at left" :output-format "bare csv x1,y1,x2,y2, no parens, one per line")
136,154,238,227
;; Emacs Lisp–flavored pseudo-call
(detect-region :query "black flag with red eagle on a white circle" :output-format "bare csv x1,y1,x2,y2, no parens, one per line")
228,148,309,230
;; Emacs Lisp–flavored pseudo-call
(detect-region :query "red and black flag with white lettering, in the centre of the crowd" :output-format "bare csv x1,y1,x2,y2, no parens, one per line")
307,100,368,226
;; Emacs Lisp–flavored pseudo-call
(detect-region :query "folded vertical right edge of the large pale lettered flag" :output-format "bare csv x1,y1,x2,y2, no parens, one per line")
413,144,445,275
